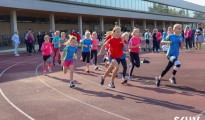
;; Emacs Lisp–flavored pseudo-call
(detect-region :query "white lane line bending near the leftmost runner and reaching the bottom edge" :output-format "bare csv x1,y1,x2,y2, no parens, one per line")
36,63,130,120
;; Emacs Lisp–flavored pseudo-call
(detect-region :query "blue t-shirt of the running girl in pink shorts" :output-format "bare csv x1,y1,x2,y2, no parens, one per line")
63,46,78,61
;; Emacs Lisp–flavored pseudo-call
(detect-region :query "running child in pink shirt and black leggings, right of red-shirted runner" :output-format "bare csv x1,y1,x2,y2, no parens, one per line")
128,28,141,80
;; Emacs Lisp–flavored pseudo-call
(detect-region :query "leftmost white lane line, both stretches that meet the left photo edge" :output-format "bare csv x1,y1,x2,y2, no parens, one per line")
0,57,39,120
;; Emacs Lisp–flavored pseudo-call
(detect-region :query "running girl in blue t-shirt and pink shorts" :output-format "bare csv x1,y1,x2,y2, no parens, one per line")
61,36,78,88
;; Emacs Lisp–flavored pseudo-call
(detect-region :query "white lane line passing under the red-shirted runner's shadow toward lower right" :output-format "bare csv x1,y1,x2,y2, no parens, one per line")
74,73,201,113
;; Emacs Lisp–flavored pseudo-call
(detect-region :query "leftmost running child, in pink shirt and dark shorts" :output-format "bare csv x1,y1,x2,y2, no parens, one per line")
41,35,53,75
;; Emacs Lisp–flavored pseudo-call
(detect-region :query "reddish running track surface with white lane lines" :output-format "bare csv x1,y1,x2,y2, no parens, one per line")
0,47,205,120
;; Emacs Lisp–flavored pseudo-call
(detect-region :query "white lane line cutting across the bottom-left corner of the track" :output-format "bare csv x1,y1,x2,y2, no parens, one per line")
0,88,35,120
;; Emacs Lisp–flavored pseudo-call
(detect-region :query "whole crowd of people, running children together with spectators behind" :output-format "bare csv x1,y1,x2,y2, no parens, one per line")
12,24,204,88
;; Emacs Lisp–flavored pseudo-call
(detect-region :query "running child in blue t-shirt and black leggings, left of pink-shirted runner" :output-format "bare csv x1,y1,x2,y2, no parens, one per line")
80,31,92,73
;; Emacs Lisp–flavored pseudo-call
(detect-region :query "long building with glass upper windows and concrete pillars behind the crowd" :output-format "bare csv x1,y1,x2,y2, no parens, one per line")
0,0,205,35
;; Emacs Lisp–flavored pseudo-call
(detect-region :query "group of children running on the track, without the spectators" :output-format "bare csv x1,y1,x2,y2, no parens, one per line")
41,24,183,88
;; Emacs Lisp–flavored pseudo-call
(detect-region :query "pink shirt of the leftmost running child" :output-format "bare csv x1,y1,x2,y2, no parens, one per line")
41,42,53,56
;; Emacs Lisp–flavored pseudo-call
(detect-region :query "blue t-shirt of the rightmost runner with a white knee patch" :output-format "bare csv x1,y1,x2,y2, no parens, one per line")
165,34,183,57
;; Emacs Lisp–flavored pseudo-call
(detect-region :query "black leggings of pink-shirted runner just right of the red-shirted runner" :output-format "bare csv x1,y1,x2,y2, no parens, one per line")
129,52,140,76
